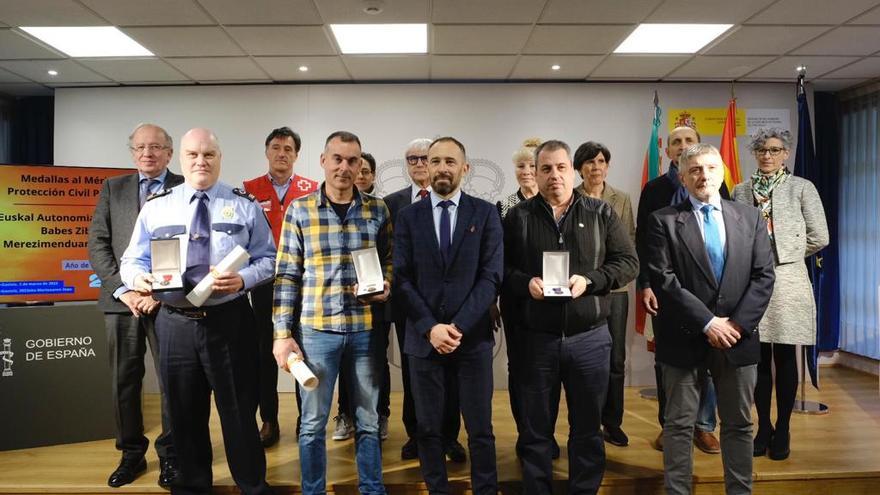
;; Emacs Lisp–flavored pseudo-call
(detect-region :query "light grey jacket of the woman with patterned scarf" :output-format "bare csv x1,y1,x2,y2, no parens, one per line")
733,175,829,265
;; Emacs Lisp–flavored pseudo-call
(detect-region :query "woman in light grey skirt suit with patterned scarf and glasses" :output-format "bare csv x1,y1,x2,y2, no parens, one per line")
733,128,828,461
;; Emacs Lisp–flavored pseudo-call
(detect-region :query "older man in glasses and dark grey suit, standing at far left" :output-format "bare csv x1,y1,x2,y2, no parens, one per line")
89,124,183,488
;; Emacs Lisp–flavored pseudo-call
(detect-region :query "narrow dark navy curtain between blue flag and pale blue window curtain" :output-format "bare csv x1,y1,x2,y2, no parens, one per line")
813,92,841,352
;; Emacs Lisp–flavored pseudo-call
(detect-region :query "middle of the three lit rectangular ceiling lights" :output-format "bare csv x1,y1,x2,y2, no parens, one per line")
330,24,428,54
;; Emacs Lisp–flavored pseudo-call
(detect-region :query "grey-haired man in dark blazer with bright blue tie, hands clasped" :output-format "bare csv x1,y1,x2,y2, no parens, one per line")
645,144,774,494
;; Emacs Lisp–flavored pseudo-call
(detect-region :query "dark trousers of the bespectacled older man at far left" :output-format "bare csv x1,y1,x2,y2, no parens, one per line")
104,313,174,459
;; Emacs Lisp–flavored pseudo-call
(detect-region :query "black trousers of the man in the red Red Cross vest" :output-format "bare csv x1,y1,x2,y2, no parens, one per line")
251,284,302,432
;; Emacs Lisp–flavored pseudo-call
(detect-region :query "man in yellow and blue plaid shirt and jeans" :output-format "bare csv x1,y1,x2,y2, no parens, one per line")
273,131,391,494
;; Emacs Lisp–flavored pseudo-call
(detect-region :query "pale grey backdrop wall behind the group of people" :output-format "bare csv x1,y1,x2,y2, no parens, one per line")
55,82,797,390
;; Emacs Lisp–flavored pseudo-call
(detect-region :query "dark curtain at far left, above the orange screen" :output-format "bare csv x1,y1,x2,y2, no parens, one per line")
9,96,55,165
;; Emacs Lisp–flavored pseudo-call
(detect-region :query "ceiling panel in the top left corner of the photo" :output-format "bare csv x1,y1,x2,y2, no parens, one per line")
0,0,107,26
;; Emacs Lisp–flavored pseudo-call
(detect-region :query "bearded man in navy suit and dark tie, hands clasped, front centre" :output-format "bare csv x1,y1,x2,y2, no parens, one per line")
393,137,503,494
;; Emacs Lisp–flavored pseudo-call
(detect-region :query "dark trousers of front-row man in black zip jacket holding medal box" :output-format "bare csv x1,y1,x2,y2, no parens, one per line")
521,325,611,494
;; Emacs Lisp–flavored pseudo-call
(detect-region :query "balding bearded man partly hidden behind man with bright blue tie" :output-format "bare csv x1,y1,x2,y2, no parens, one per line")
636,127,730,454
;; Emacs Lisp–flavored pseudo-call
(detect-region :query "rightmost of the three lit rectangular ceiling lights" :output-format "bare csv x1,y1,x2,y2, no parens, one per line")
614,24,733,53
